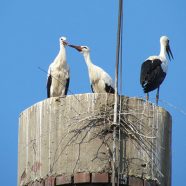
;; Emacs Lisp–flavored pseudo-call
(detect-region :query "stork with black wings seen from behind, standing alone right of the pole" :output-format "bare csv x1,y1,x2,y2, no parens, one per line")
140,36,174,105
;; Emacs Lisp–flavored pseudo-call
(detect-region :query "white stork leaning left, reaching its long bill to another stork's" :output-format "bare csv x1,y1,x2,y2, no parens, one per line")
69,45,115,94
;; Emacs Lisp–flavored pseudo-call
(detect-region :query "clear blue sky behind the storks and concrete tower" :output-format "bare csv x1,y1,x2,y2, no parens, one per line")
0,0,186,186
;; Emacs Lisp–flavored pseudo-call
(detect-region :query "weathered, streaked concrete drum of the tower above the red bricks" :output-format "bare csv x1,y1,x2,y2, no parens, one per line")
18,94,171,186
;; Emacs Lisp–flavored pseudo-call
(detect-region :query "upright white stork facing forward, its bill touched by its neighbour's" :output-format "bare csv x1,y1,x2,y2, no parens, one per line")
47,37,70,98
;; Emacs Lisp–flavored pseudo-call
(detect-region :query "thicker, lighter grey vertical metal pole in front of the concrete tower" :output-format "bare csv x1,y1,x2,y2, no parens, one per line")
112,0,123,186
